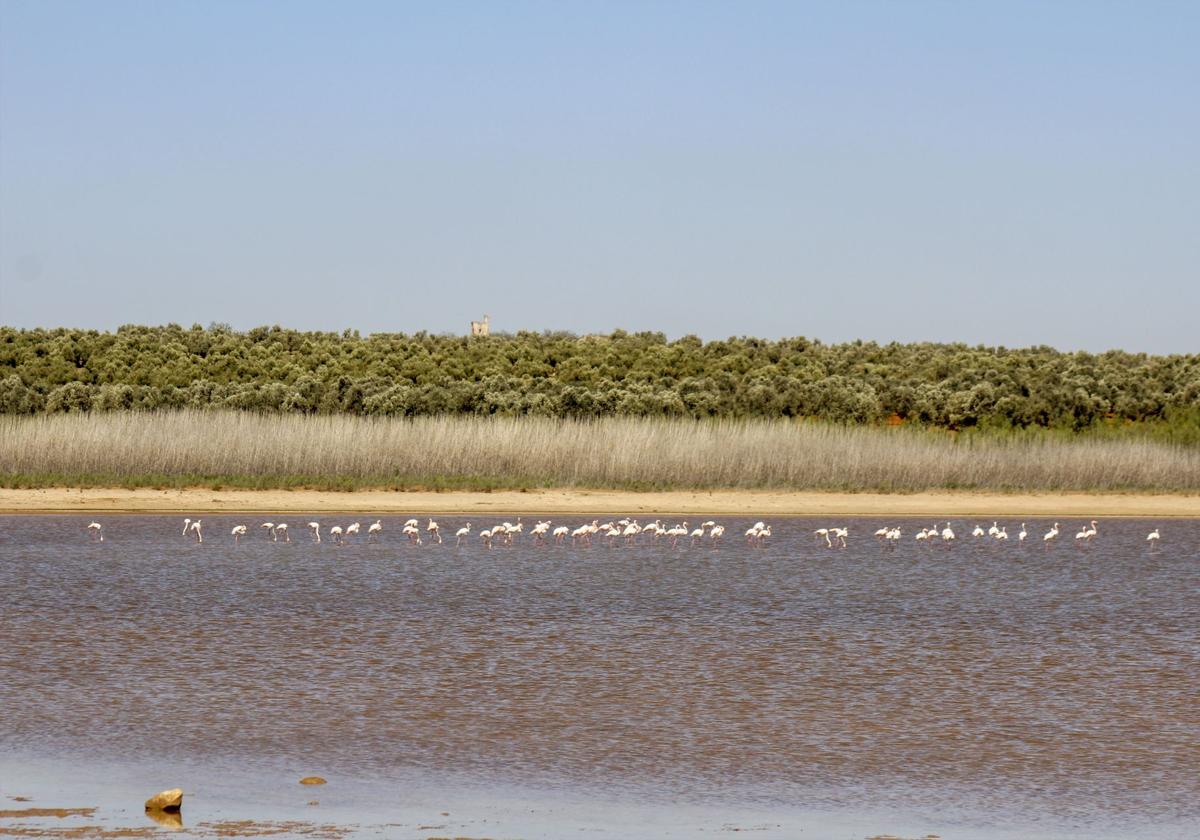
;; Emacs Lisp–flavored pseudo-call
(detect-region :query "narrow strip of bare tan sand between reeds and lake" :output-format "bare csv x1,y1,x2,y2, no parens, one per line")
0,488,1200,517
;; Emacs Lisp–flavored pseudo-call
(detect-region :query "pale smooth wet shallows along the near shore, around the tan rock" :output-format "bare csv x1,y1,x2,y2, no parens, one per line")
0,755,1152,840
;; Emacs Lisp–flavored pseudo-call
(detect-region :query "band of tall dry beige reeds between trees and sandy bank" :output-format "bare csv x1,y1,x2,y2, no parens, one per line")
0,412,1200,492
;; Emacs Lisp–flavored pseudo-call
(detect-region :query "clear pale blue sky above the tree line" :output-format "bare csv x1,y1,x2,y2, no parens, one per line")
0,0,1200,353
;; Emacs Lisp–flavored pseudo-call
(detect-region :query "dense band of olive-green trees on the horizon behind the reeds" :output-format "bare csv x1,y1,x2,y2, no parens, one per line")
0,324,1200,431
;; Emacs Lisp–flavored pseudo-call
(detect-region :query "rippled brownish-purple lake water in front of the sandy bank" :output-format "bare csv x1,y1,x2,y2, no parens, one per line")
0,516,1200,836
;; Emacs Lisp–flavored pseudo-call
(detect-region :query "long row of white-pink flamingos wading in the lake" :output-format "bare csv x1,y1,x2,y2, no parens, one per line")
88,516,1162,550
